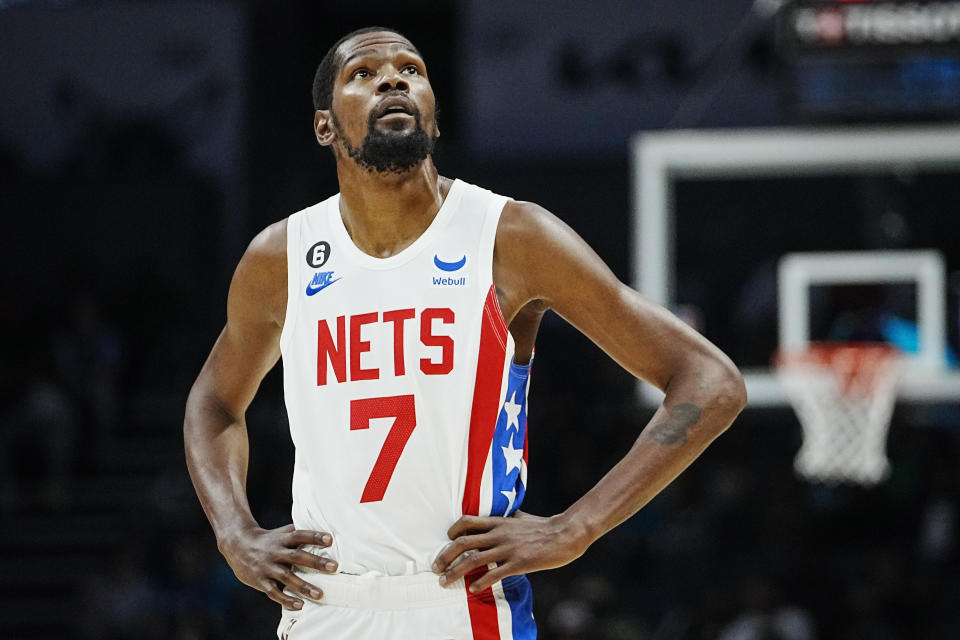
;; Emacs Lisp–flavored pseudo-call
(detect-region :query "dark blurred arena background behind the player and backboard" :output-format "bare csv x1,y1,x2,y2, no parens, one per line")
0,0,960,640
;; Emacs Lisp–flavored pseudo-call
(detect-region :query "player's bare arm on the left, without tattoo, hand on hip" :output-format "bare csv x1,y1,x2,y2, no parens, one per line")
183,221,336,609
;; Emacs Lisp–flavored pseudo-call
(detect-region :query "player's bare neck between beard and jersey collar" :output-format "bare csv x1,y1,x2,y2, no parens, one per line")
337,157,451,258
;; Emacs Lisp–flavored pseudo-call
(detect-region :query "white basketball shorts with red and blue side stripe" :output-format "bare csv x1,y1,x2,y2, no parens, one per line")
277,573,537,640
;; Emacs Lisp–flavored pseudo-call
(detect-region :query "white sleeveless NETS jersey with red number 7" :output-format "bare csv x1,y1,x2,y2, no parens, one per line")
280,180,529,575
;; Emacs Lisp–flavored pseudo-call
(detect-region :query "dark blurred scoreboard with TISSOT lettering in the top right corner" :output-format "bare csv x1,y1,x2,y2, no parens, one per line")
777,0,960,121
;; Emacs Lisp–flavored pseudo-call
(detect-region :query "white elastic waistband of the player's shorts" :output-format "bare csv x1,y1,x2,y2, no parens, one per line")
297,571,469,609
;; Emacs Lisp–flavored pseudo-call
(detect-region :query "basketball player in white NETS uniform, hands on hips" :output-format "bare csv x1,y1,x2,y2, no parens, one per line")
184,28,745,640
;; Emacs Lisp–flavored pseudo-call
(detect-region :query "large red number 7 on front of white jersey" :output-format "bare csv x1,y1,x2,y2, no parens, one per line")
350,395,417,502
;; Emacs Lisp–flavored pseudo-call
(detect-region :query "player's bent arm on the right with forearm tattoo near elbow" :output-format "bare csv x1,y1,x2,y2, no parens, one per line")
434,203,746,592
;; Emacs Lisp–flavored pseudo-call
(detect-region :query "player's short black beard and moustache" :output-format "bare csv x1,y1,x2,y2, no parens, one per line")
332,111,436,173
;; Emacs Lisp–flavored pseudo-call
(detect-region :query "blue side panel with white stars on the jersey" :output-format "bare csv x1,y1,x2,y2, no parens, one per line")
490,363,530,516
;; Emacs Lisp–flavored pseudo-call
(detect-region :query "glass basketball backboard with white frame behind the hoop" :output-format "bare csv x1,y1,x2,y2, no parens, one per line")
633,126,960,406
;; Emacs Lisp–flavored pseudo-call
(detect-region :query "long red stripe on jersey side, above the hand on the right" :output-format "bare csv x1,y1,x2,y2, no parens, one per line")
463,285,507,516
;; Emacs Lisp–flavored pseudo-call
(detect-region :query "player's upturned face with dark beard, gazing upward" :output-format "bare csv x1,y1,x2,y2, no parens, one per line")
330,31,439,173
